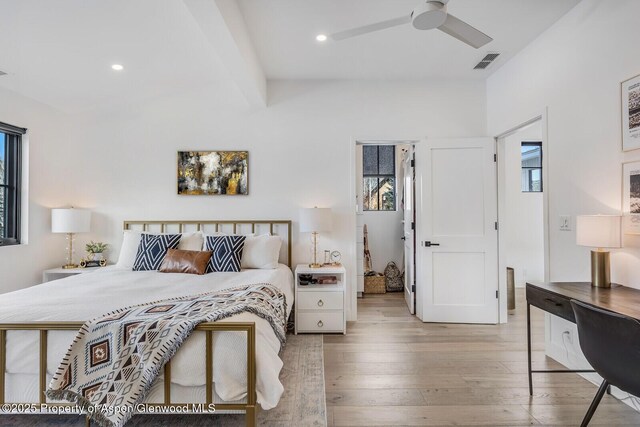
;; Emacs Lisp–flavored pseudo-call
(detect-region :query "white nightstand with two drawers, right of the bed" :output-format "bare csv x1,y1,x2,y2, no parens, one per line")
295,264,347,334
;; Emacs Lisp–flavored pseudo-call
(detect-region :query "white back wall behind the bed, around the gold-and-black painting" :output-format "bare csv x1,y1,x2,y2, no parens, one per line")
51,81,486,320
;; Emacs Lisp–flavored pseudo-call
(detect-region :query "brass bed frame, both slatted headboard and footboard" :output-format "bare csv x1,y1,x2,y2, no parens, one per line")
0,220,292,427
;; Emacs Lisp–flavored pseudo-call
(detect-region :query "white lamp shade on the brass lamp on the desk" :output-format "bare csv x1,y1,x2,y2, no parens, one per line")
576,215,621,248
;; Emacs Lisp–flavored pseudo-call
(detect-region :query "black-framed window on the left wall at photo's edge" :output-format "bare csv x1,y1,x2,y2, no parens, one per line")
0,122,26,246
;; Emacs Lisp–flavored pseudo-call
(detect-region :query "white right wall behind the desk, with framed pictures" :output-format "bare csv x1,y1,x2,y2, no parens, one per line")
487,0,640,390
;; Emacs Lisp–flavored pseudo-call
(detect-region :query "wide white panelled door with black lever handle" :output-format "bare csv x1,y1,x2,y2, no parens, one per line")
415,138,498,323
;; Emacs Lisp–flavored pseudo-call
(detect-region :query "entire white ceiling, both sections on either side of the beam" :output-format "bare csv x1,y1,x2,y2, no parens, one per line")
0,0,578,112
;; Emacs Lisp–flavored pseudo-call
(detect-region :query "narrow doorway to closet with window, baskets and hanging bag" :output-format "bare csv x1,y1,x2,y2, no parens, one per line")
355,140,415,314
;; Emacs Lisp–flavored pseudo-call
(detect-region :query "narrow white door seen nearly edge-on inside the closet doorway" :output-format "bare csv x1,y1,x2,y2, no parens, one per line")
402,147,416,314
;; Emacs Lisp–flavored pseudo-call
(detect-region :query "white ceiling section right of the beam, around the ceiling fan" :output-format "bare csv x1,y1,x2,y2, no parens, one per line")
240,0,579,79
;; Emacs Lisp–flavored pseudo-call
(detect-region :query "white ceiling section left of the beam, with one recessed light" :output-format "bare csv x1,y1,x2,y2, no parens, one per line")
0,0,232,112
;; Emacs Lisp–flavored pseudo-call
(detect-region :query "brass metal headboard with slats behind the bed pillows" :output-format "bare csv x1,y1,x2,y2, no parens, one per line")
123,219,292,268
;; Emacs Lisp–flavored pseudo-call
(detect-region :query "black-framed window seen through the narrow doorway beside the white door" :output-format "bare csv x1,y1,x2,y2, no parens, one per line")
362,145,396,211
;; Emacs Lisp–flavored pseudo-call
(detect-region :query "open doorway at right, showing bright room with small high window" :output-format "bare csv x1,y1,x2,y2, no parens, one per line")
496,116,548,322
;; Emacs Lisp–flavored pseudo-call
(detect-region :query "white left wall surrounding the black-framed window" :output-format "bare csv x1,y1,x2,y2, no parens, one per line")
0,88,75,293
